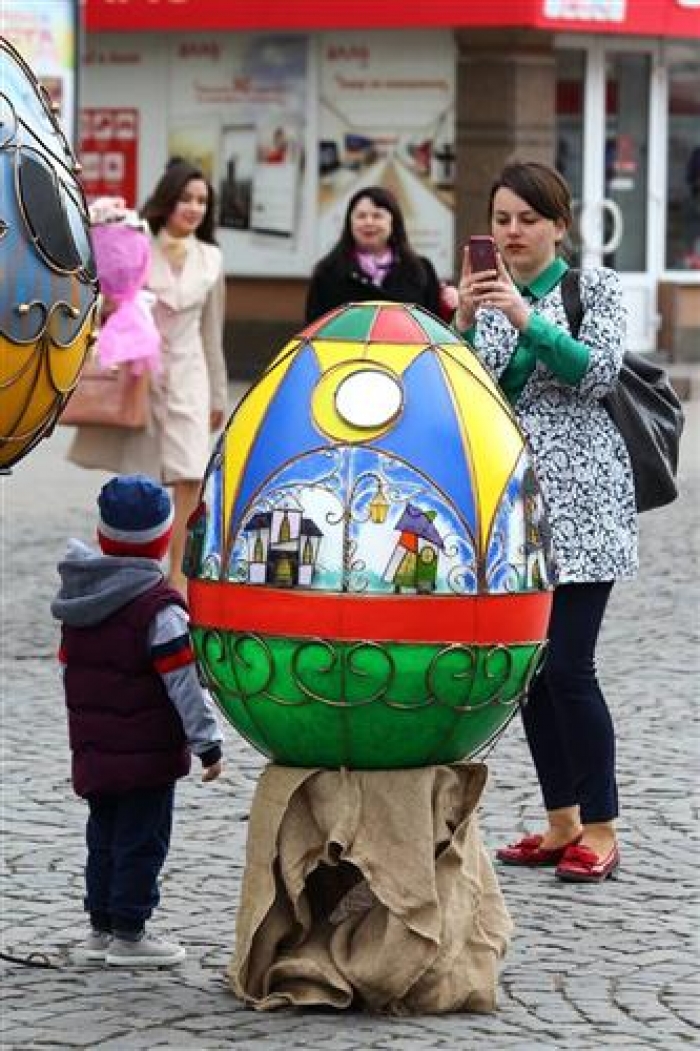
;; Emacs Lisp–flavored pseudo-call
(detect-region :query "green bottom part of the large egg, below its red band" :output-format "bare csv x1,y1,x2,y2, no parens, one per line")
191,626,543,769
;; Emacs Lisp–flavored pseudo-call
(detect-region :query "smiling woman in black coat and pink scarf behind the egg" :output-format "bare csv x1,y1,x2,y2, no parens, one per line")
306,186,440,322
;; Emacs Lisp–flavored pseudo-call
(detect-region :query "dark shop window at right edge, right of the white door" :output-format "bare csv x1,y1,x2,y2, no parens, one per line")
666,44,700,270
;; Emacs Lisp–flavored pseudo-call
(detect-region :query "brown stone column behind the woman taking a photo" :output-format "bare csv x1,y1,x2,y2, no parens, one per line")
455,29,556,274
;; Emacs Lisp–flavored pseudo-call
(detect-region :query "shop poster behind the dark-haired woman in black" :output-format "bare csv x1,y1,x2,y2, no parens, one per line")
317,30,456,277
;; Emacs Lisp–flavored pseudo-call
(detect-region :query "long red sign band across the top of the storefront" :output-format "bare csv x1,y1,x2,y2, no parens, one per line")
81,0,700,39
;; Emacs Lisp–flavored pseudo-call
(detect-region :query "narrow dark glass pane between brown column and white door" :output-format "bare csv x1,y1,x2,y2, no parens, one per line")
556,51,585,266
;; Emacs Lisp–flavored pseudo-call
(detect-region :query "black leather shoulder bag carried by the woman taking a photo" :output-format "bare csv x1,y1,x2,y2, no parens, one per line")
561,269,685,513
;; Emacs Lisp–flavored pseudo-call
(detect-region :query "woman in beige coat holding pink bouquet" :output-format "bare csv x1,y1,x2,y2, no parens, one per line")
68,160,227,592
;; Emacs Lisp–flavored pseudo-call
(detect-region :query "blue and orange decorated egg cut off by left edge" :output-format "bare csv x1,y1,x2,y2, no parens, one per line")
0,38,98,469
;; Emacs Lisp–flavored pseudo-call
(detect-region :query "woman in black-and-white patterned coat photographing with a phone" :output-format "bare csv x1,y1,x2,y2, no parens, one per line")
455,163,637,882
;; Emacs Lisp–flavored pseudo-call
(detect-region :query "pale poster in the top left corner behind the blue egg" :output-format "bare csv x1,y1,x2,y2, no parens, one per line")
0,0,77,143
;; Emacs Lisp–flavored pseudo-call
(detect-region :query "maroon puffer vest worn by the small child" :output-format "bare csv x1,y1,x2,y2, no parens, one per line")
61,581,190,796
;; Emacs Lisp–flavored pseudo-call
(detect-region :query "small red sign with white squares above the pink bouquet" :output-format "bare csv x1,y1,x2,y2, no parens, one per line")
79,108,139,208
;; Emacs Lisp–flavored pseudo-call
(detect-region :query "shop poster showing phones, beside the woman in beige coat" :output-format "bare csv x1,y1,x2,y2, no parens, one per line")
167,34,310,275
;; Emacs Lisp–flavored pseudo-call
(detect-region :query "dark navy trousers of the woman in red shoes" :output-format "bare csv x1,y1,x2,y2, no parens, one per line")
522,582,618,824
